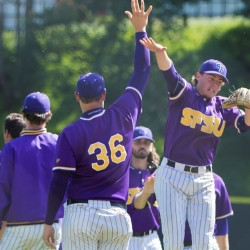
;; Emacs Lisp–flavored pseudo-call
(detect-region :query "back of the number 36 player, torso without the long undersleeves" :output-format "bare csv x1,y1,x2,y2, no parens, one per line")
54,90,141,202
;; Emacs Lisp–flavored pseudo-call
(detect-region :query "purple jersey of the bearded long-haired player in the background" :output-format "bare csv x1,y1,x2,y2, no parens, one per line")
127,167,160,232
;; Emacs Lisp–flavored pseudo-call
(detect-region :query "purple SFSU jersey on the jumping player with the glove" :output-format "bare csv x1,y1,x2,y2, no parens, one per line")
163,65,244,166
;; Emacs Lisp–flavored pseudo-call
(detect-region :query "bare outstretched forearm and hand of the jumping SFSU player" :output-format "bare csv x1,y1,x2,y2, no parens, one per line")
140,37,172,71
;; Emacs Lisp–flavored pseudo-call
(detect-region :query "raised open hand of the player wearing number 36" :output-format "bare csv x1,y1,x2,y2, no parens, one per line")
125,0,153,32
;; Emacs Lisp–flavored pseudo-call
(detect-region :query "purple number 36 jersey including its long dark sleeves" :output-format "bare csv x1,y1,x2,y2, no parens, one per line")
46,32,150,224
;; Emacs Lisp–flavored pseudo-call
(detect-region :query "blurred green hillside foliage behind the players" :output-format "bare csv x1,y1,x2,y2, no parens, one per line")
0,16,250,196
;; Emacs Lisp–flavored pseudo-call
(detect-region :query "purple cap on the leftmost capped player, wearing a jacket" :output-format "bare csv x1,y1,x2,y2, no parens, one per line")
23,92,50,114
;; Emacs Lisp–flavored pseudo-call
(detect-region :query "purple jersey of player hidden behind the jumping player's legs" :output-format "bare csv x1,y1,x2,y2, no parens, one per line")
184,173,233,242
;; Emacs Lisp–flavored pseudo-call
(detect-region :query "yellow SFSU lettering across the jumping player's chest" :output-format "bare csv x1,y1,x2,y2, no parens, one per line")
181,108,226,137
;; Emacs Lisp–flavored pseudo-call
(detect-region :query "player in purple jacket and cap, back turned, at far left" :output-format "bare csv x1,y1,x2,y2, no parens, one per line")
0,92,63,250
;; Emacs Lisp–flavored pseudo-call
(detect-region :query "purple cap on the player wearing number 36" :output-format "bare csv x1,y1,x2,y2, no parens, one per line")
76,73,105,98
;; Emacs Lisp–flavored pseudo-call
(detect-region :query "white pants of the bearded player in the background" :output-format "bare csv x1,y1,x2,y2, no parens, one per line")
128,231,162,250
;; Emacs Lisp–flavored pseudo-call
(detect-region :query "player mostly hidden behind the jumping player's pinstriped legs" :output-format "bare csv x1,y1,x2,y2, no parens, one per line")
184,173,233,250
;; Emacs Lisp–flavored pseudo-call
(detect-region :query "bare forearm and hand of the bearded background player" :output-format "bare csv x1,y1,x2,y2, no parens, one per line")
134,176,155,209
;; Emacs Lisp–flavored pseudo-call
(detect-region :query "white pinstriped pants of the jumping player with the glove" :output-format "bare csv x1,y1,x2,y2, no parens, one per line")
155,164,215,250
